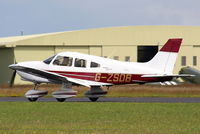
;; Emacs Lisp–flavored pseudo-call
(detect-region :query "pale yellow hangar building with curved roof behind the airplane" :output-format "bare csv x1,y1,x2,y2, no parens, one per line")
0,26,200,84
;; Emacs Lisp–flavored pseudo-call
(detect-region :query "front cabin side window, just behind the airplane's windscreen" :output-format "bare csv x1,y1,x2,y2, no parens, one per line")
53,56,73,66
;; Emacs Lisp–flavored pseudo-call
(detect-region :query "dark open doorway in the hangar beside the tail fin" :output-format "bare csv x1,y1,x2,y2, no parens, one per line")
137,46,158,62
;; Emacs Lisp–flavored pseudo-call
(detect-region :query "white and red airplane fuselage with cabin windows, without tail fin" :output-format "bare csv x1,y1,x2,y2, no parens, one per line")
12,52,172,84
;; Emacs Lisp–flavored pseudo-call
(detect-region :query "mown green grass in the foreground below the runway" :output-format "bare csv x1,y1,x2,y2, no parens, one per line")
0,102,200,134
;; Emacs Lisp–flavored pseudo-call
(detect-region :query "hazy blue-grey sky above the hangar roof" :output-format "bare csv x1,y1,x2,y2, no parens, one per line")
0,0,200,37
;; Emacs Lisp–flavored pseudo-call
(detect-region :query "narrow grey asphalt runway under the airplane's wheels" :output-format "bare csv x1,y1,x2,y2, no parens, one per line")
0,97,200,103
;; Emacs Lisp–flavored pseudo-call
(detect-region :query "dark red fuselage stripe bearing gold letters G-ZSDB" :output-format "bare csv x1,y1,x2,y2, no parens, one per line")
49,71,172,84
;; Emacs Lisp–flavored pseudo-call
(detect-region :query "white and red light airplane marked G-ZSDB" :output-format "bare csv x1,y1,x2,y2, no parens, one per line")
9,39,191,102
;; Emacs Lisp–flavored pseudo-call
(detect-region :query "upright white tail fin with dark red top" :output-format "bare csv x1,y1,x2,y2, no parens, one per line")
145,39,182,73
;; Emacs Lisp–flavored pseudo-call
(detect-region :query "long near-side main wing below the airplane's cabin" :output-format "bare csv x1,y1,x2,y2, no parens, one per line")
10,66,112,87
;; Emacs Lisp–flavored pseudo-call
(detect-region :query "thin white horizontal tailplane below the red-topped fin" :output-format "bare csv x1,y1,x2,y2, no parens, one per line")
141,74,195,78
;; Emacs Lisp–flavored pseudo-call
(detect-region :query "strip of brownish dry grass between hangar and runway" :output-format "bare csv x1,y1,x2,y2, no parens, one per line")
0,85,200,97
